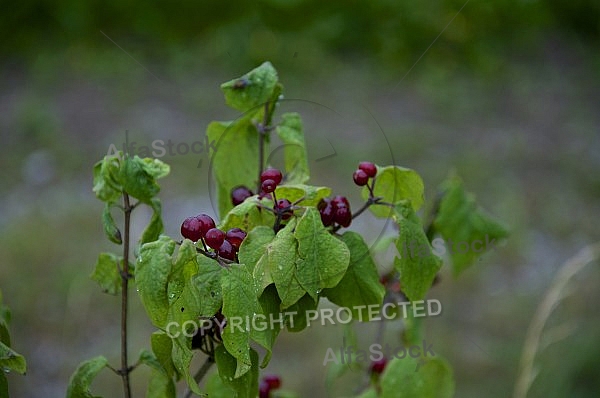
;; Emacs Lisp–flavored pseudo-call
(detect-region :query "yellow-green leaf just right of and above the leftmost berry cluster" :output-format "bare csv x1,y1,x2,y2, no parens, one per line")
219,196,275,238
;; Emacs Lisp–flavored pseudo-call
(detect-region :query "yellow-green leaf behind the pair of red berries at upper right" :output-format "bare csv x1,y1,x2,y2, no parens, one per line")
362,166,425,218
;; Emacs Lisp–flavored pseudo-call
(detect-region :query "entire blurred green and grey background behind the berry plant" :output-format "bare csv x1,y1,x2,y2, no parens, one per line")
0,0,600,398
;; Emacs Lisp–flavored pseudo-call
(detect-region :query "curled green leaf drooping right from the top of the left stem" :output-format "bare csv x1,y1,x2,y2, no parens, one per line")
119,155,160,203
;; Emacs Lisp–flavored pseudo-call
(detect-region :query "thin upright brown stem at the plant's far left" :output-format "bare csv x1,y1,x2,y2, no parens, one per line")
119,193,137,398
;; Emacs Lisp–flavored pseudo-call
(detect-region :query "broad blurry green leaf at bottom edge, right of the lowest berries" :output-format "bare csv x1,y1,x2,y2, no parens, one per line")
380,356,454,398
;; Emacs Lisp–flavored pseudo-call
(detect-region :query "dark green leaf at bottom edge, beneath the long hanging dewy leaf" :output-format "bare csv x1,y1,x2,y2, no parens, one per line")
214,345,258,398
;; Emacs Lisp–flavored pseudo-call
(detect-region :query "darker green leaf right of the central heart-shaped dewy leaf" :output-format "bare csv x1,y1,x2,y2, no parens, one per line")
323,231,385,321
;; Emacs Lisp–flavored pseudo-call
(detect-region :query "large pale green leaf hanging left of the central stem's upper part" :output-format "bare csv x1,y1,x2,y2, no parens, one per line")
206,117,259,217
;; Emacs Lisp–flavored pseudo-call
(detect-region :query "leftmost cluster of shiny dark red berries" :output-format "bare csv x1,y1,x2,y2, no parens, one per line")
181,214,246,261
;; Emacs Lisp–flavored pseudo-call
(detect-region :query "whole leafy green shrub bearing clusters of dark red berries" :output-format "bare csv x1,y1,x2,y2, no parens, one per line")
67,63,506,398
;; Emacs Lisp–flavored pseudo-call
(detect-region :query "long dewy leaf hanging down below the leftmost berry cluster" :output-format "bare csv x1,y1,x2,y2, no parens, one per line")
221,265,270,378
